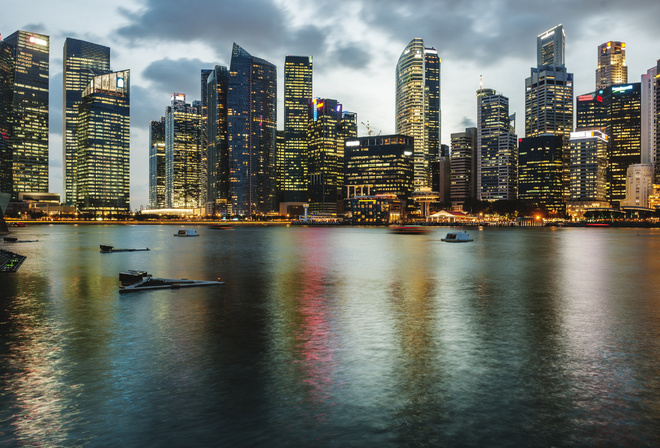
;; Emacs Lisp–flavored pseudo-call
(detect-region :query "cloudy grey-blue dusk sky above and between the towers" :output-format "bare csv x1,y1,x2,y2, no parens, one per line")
0,0,660,210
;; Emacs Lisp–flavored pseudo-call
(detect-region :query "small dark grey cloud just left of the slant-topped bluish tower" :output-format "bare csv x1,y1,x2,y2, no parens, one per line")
142,58,222,100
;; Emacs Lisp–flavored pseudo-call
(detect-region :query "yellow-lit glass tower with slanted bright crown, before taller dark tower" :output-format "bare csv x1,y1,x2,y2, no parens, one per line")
75,70,131,216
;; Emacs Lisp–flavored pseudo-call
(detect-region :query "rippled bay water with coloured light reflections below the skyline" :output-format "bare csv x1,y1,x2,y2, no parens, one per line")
0,225,660,448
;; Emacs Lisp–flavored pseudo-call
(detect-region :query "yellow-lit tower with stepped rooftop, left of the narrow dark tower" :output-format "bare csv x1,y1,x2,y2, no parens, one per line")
165,93,202,209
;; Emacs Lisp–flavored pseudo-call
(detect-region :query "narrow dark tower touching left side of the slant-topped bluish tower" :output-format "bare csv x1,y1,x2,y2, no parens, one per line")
206,65,231,215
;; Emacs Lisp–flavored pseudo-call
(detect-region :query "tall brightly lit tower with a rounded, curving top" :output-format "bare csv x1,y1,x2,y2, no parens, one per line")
395,38,441,189
